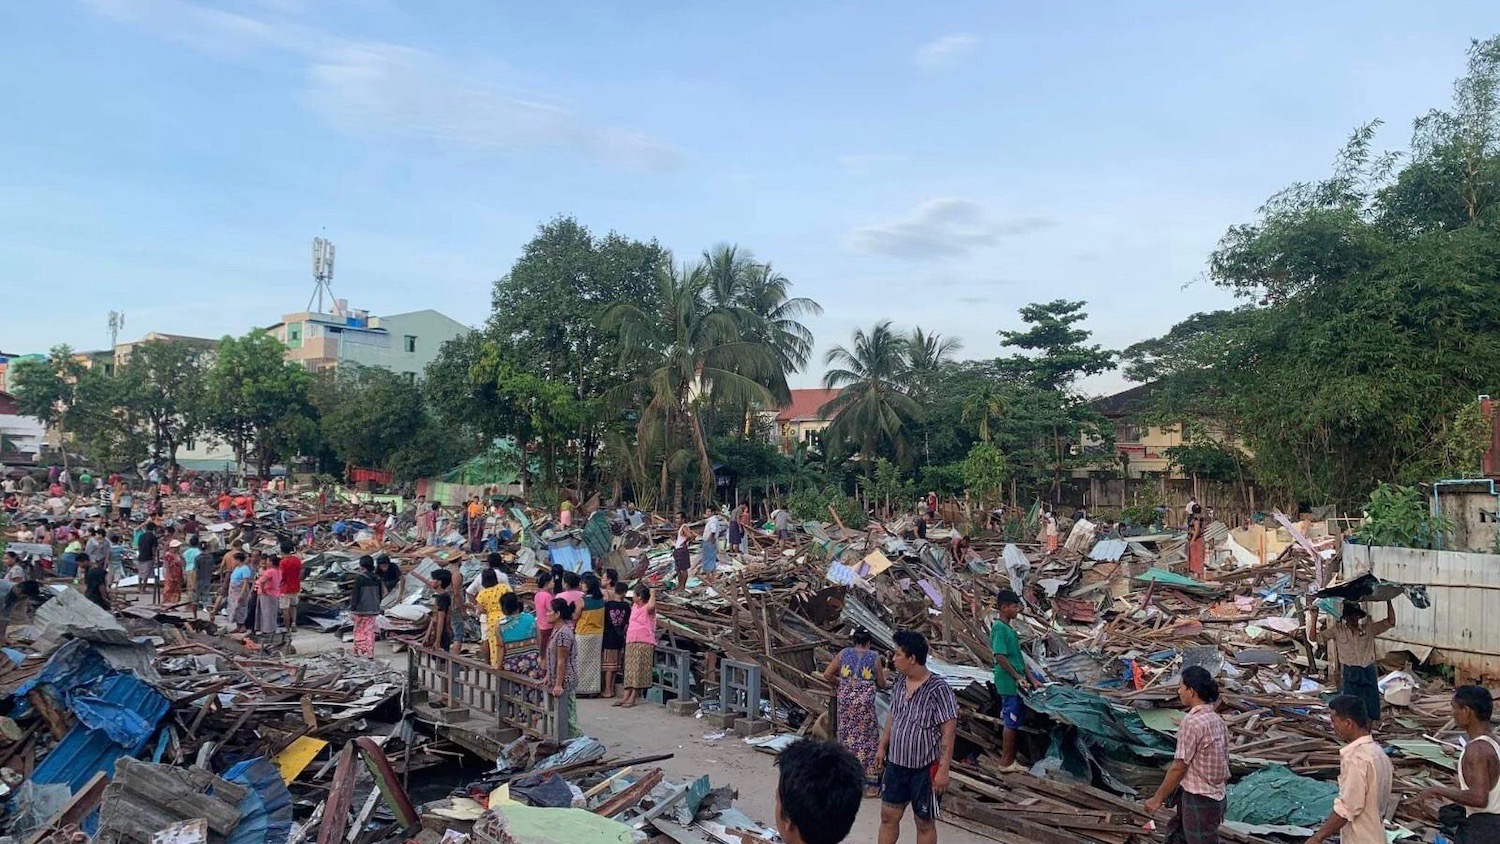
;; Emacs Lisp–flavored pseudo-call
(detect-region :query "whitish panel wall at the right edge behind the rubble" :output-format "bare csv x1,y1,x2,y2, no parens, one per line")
1344,543,1500,678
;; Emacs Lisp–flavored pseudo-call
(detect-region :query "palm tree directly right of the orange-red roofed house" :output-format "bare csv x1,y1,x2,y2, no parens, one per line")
824,321,921,474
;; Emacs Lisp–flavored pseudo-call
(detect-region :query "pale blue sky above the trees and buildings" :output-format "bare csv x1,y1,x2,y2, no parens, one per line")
0,0,1500,391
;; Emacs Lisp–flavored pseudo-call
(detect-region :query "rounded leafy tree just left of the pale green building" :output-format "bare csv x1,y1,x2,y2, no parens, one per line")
206,330,317,477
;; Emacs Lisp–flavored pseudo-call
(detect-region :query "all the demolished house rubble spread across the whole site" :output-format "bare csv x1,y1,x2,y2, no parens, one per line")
0,482,1482,844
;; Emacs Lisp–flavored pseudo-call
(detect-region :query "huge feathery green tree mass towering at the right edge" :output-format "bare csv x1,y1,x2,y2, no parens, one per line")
1127,39,1500,505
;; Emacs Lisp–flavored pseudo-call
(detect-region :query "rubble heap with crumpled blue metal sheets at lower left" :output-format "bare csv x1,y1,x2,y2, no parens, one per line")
0,588,444,844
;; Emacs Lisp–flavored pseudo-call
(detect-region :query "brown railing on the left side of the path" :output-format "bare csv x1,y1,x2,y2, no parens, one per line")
407,645,567,742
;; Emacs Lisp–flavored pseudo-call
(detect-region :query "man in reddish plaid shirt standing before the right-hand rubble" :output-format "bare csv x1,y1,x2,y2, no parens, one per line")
1146,666,1229,844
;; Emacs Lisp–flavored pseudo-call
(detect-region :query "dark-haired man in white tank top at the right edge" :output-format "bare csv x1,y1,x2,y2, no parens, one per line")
1419,685,1500,844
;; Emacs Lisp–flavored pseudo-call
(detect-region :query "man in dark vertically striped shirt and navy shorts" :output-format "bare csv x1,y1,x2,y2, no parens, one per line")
875,630,959,844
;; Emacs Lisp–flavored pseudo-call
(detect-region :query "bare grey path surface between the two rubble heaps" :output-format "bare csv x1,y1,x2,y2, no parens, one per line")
578,699,990,844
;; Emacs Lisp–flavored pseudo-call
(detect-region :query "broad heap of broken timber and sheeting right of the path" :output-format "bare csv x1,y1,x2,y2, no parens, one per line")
591,514,1457,844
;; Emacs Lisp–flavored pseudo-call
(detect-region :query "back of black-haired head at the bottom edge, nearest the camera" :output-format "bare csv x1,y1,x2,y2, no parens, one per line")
776,739,860,844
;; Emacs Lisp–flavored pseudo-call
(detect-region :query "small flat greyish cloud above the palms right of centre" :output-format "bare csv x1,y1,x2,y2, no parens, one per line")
849,196,1056,261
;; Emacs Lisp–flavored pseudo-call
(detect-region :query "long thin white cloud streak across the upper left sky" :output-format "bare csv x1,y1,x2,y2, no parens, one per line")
84,0,683,171
